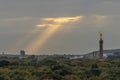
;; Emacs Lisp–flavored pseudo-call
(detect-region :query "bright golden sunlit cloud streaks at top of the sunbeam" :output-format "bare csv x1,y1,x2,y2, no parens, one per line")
36,16,83,27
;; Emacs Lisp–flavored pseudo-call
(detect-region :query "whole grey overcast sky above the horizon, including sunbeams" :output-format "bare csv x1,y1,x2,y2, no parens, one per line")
0,0,120,54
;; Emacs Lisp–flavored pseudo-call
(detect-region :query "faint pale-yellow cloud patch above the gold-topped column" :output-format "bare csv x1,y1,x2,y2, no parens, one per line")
82,15,109,29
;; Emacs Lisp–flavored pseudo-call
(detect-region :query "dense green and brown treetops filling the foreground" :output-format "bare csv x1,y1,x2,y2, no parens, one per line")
0,57,120,80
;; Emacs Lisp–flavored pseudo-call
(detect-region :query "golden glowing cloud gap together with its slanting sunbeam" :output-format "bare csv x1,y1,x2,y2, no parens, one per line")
26,16,83,54
